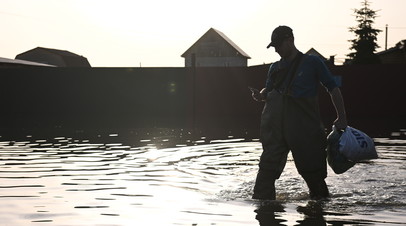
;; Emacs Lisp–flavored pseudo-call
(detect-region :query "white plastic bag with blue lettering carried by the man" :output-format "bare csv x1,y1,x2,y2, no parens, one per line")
338,126,378,162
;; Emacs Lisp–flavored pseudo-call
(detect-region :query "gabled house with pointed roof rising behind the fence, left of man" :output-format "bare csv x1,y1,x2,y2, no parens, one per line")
182,28,251,67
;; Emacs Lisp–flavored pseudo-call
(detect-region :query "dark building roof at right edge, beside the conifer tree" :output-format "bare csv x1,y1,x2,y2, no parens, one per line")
376,39,406,64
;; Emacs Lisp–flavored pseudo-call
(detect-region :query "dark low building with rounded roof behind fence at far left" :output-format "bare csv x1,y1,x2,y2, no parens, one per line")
16,47,91,67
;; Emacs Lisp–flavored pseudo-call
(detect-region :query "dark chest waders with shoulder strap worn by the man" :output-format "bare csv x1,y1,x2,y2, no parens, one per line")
253,53,328,199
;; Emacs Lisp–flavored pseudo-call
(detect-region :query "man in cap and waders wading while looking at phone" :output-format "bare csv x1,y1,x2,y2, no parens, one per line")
251,26,347,200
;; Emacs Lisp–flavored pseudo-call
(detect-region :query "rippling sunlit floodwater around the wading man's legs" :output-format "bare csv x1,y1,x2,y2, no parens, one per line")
0,130,406,226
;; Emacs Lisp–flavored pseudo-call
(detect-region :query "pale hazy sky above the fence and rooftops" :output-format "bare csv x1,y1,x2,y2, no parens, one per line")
0,0,406,67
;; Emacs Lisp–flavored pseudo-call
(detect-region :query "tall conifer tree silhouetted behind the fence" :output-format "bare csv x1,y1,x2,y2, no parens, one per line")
347,0,382,64
